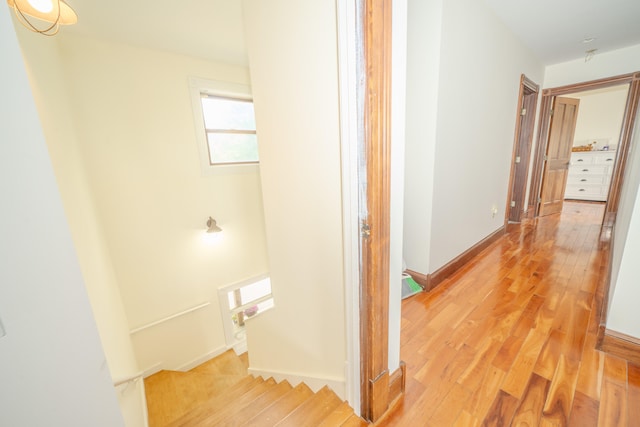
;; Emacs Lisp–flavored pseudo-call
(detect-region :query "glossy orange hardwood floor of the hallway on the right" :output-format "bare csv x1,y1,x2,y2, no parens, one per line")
379,202,640,427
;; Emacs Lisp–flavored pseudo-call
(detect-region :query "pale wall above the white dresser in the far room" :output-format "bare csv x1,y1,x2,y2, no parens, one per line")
567,84,629,149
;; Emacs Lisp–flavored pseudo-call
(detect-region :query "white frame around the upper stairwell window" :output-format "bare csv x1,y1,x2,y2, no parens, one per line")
189,77,260,175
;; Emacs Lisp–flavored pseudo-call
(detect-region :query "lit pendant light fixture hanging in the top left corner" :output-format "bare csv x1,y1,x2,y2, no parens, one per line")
7,0,78,36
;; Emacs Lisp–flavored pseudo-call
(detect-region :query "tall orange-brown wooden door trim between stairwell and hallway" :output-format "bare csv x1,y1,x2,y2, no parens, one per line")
358,0,392,422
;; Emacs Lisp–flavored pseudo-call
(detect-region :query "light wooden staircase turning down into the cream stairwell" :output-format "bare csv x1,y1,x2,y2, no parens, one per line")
145,352,368,427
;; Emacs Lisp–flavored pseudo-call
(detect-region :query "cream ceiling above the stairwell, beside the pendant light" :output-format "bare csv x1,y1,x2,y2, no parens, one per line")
61,0,248,65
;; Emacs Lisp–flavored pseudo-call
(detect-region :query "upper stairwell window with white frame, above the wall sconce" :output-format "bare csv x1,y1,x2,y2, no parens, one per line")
189,78,258,174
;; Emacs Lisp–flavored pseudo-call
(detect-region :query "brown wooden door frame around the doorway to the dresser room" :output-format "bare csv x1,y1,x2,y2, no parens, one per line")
528,72,640,219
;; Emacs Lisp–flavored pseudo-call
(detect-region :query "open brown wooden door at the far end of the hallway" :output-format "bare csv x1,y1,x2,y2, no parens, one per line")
539,97,580,216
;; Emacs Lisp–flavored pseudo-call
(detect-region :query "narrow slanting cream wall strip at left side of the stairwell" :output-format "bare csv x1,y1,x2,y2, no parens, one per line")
16,28,146,426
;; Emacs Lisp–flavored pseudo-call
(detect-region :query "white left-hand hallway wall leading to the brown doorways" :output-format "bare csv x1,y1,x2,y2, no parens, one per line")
405,0,543,273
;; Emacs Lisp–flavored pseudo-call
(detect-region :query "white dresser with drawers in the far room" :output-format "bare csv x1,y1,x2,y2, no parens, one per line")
564,151,616,201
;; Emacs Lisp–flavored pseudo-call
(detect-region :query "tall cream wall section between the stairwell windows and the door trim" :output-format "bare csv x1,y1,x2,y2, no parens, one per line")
243,0,346,396
